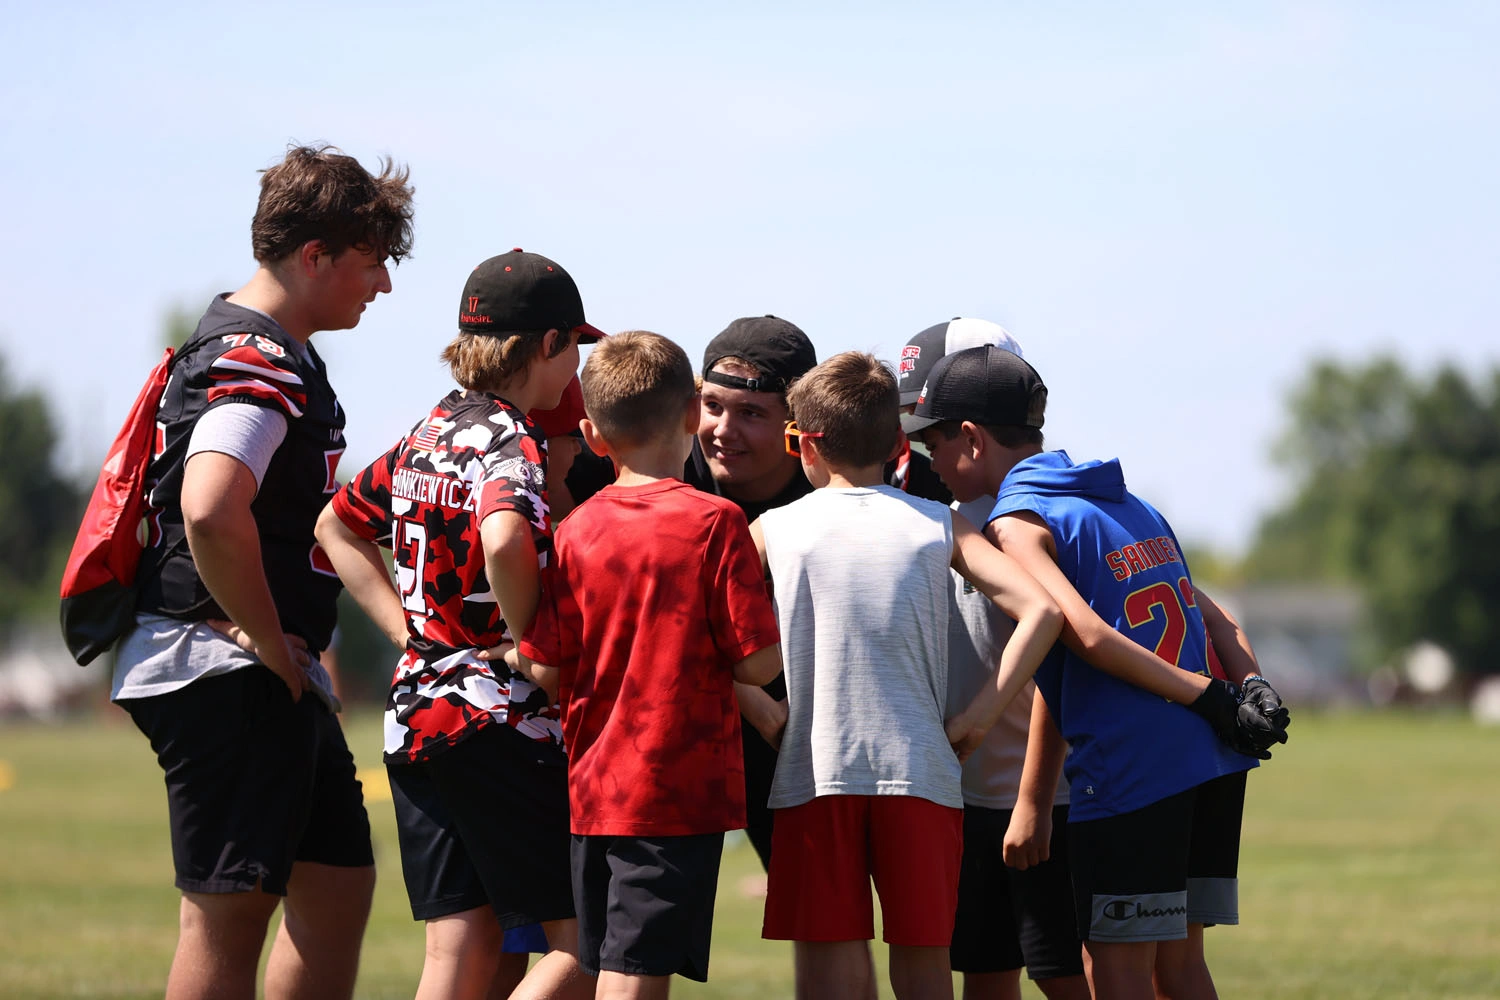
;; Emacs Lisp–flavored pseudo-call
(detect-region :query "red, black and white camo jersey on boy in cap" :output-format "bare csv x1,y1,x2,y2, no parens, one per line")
333,390,563,762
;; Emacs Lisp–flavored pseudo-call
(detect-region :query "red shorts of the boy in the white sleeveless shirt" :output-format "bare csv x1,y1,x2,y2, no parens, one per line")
762,795,963,948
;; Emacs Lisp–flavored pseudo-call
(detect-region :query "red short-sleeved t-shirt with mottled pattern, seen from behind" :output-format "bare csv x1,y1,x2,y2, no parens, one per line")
521,480,780,837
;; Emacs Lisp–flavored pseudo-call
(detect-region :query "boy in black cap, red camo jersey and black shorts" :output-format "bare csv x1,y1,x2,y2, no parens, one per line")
317,249,602,1000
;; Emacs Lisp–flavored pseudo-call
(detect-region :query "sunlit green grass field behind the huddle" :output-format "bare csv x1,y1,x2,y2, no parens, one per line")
0,709,1500,1000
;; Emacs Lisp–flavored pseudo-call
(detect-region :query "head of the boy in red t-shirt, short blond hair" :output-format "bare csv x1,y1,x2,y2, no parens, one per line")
579,330,698,445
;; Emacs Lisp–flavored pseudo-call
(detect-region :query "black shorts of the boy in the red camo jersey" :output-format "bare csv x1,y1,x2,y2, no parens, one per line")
386,724,573,931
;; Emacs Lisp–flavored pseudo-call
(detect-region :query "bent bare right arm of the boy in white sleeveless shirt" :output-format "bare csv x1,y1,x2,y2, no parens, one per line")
947,514,1062,760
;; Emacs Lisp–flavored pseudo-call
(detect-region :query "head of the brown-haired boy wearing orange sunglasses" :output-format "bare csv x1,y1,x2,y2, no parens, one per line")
786,351,902,468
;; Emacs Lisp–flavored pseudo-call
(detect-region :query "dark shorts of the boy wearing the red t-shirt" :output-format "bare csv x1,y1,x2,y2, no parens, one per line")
573,834,725,982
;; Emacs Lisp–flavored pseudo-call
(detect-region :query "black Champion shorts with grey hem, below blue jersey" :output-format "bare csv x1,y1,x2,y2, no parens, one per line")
1068,771,1245,942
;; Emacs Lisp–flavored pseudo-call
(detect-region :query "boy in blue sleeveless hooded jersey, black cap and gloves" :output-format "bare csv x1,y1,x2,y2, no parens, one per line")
902,346,1287,999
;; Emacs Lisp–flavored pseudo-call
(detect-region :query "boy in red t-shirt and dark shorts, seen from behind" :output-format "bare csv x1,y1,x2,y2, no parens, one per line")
518,331,782,997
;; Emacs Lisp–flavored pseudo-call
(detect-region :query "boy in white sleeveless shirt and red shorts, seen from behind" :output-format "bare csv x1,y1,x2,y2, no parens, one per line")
752,352,1062,1000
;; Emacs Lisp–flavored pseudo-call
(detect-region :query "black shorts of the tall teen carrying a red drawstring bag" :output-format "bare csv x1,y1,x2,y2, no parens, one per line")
119,666,375,895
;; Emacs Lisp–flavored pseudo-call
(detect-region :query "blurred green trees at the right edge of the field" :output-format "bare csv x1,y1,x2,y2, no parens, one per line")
1244,357,1500,673
